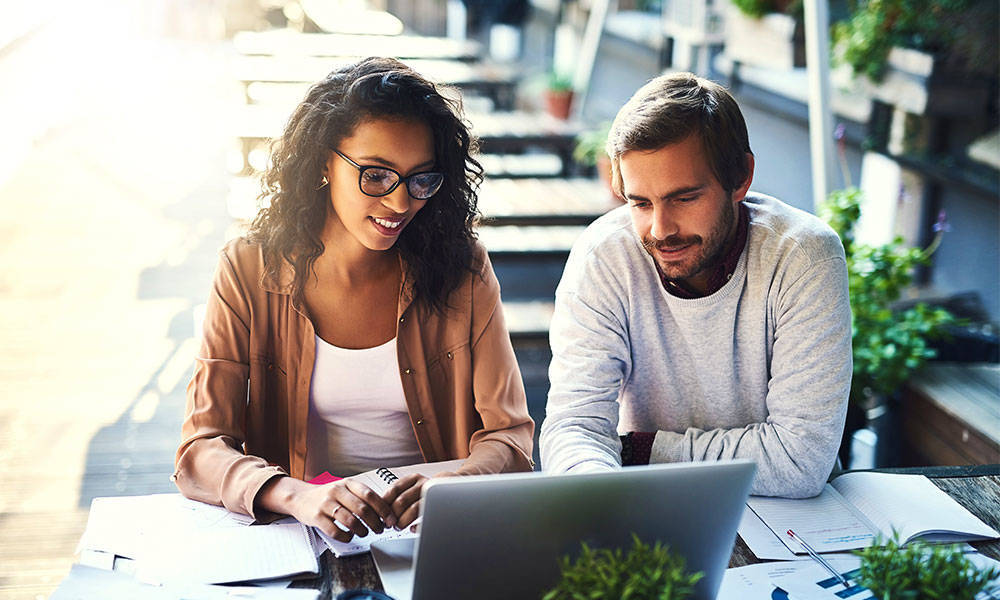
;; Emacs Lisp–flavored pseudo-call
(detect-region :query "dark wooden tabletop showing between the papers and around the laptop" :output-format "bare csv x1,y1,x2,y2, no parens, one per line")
292,464,1000,600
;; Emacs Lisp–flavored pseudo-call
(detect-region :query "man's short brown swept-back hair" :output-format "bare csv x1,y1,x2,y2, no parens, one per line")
606,73,751,196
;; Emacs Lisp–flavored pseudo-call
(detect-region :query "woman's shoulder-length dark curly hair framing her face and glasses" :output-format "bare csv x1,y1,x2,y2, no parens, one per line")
247,58,483,311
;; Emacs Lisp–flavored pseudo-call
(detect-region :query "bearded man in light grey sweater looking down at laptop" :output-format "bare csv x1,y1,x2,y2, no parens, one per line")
541,73,851,497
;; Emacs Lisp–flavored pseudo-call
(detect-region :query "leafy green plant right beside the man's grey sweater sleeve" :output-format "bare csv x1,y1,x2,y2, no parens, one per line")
819,187,956,466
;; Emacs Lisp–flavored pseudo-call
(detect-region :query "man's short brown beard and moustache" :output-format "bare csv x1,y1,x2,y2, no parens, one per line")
642,199,736,280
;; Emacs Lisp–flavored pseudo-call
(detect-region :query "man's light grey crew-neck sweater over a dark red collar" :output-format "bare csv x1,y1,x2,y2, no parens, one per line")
541,194,851,497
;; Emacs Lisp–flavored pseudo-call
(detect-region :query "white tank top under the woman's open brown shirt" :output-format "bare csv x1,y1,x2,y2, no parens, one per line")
305,335,423,480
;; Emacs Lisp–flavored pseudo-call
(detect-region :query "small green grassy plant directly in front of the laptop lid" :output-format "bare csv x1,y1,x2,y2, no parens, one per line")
542,533,704,600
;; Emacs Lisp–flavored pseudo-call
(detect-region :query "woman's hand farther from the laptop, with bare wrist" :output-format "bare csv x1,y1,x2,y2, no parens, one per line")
258,477,394,542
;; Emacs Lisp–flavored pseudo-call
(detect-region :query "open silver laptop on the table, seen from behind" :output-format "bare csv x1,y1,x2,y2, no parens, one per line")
372,460,756,600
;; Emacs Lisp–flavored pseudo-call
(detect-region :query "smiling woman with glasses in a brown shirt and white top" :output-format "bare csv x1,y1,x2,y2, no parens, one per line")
174,58,534,541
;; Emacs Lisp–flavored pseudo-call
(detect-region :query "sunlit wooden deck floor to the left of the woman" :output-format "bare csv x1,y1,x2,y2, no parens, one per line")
0,10,241,600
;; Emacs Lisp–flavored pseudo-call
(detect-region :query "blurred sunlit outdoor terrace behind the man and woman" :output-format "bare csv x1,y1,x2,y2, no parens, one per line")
0,0,1000,599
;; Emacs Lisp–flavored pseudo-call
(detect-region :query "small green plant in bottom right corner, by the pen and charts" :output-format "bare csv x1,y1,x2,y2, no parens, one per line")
855,533,1000,600
